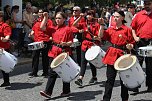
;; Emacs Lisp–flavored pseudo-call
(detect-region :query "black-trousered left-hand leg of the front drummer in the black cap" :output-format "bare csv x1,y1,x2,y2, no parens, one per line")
103,65,117,101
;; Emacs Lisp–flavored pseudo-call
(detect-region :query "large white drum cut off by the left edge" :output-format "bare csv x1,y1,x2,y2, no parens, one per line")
0,49,17,73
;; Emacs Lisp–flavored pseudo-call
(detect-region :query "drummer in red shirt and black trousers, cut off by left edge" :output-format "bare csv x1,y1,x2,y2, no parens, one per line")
0,11,12,87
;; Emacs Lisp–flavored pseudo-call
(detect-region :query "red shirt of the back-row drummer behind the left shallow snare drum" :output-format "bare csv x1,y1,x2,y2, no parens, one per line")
32,18,53,42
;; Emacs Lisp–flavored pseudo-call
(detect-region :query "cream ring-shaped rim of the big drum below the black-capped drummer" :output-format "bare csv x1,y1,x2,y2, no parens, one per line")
114,54,137,71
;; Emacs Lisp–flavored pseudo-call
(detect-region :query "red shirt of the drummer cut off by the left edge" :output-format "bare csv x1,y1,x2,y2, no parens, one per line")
0,22,12,49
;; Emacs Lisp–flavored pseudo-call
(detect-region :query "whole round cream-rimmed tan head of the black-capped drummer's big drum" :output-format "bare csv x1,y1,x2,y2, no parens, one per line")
114,54,137,70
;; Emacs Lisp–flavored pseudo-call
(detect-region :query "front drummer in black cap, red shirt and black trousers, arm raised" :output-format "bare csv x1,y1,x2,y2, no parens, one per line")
100,11,134,101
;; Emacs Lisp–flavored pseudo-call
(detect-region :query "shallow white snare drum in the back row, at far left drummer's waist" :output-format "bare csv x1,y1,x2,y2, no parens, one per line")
28,42,45,50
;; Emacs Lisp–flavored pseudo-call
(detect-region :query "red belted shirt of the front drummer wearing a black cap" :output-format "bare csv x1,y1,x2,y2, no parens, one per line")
102,25,135,65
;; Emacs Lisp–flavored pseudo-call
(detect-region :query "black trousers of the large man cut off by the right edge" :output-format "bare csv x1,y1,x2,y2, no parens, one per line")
135,39,152,88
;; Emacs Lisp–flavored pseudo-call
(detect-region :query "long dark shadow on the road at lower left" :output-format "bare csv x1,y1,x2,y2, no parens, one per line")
5,82,42,90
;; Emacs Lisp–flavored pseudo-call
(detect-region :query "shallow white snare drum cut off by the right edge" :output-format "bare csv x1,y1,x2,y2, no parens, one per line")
138,46,152,57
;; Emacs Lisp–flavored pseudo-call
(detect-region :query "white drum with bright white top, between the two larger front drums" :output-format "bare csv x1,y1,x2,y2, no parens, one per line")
85,46,105,68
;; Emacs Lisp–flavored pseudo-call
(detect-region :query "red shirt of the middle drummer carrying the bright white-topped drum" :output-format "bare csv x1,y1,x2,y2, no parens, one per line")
81,22,100,51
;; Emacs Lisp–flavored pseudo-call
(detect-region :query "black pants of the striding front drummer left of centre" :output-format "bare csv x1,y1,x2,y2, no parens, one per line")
45,58,70,94
